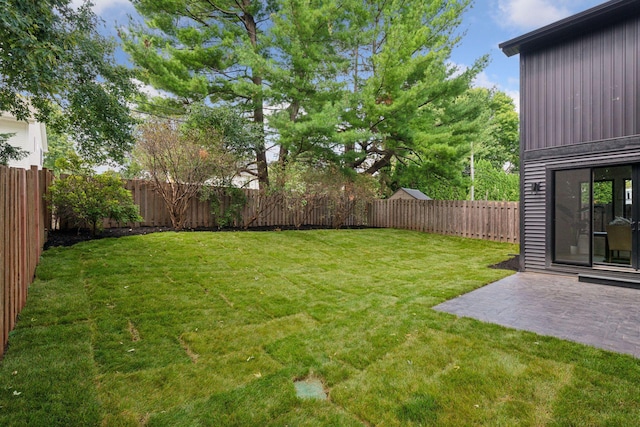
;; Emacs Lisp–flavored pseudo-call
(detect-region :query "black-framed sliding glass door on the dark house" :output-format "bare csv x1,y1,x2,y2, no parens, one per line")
553,165,640,269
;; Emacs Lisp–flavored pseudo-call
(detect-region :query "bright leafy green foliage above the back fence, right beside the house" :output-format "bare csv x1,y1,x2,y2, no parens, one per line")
390,88,519,200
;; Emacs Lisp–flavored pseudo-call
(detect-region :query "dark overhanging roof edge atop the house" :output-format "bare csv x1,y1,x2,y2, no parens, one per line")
499,0,640,56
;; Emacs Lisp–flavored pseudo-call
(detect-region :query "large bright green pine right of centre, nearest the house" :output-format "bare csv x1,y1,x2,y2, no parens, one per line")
341,0,486,174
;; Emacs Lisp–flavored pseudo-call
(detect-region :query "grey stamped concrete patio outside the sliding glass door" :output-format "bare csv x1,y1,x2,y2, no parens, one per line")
434,272,640,357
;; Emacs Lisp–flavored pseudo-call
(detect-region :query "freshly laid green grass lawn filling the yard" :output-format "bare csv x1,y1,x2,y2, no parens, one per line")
0,230,640,426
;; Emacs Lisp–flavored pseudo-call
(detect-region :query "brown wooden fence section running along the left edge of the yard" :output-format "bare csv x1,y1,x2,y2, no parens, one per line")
0,166,52,356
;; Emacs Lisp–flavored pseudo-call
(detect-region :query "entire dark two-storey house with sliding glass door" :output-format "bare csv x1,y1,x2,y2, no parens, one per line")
500,0,640,281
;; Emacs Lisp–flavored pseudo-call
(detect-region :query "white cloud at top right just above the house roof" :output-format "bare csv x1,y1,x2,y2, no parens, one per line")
498,0,571,29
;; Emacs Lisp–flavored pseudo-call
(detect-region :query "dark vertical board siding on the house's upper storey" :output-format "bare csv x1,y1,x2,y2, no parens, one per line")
521,18,640,151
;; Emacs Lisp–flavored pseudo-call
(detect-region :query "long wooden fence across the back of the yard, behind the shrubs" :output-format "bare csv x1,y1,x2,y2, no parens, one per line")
105,180,520,243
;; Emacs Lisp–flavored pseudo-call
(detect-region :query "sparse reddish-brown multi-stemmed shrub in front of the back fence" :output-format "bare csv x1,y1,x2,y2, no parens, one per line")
134,107,254,230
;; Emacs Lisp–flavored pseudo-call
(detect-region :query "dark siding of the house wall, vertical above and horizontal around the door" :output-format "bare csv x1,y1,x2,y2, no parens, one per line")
520,16,640,269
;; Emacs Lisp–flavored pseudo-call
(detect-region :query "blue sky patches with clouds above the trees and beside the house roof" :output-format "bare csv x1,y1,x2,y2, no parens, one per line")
79,0,604,110
